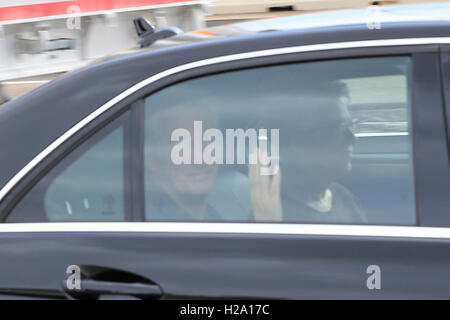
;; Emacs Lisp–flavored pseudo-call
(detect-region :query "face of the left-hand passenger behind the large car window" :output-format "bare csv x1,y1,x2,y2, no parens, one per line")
147,108,217,195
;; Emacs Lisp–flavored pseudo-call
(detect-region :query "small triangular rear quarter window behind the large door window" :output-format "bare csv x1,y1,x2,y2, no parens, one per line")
6,112,129,222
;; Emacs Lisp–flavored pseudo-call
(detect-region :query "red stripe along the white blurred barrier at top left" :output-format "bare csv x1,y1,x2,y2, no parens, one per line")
0,0,192,21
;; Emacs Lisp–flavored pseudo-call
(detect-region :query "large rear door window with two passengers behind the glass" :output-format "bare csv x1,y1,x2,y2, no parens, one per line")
144,57,416,225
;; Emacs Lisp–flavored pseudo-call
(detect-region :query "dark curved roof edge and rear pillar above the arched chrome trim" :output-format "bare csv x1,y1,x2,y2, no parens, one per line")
0,4,450,198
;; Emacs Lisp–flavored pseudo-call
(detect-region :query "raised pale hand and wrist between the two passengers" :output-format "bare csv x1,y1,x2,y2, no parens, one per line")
248,151,283,221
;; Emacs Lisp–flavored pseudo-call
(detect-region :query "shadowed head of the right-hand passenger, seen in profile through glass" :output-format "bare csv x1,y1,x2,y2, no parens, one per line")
280,99,355,183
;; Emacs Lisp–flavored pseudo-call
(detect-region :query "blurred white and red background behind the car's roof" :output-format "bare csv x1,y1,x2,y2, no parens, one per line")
0,0,448,104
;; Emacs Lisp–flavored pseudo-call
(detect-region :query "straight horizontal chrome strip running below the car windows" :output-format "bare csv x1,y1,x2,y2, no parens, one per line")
0,222,450,239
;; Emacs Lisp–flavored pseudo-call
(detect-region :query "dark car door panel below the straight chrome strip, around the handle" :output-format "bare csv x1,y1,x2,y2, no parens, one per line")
0,233,450,299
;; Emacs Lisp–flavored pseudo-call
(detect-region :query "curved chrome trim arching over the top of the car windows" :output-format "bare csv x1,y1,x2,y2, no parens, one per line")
0,37,450,220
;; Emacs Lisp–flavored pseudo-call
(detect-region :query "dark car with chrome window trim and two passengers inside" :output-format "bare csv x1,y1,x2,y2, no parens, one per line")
0,3,450,299
